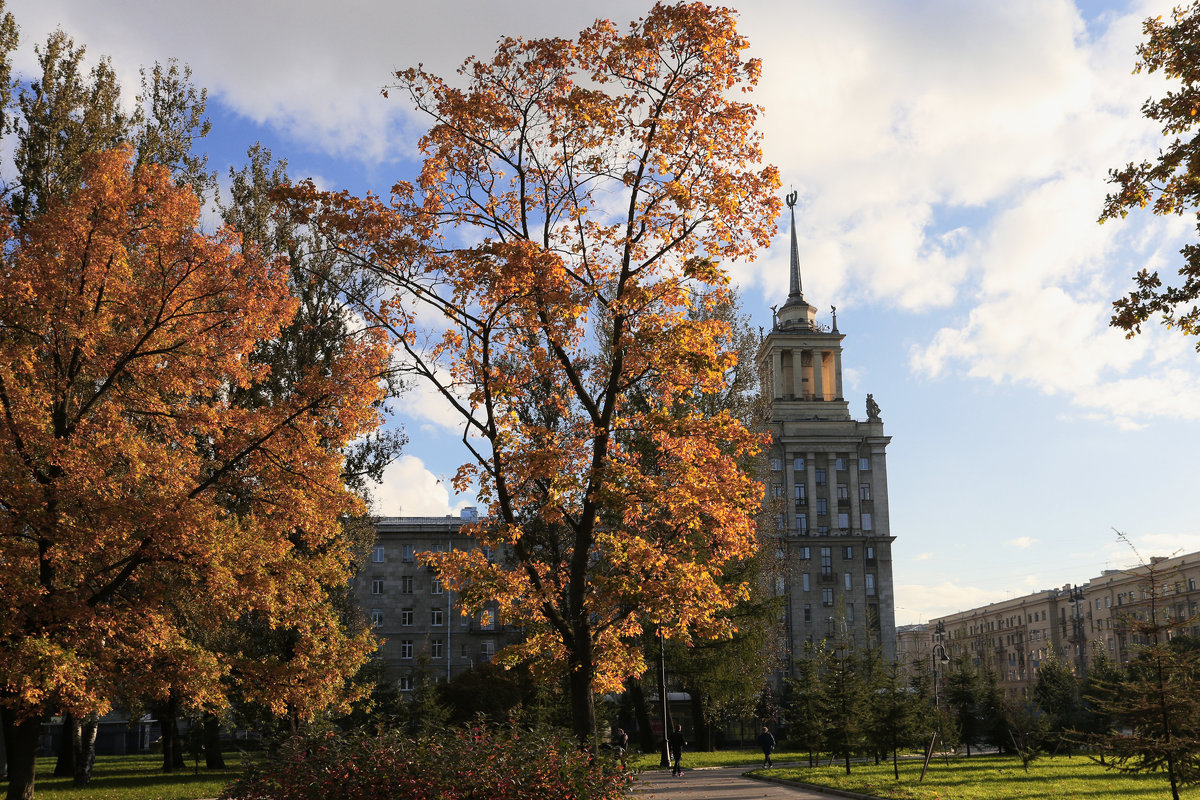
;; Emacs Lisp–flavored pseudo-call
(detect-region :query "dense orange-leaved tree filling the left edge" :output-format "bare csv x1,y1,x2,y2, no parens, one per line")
0,149,388,800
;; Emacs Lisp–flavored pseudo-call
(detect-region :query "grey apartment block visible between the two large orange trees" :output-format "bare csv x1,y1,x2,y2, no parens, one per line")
354,509,520,691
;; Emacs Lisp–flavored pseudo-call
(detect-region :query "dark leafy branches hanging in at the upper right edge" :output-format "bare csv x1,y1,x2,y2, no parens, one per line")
1100,0,1200,349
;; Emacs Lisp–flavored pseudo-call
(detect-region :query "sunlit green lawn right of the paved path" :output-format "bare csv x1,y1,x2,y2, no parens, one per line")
756,756,1180,800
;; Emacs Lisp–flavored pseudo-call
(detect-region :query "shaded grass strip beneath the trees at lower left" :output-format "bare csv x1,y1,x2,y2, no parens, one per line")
0,753,241,800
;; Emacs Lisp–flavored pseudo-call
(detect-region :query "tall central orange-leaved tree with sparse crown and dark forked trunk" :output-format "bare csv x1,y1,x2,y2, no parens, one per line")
293,4,779,742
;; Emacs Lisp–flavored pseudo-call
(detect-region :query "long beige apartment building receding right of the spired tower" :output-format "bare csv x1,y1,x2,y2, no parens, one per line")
901,553,1200,698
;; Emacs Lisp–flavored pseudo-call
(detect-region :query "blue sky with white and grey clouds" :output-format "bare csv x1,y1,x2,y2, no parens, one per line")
7,0,1200,625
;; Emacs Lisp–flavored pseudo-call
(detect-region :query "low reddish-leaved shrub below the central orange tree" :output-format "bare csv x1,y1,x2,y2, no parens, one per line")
222,726,631,800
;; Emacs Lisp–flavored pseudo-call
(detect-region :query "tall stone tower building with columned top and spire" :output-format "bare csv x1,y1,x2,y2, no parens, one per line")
758,193,895,658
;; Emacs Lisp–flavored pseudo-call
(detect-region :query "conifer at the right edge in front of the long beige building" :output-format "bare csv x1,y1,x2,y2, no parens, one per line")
1088,546,1200,800
